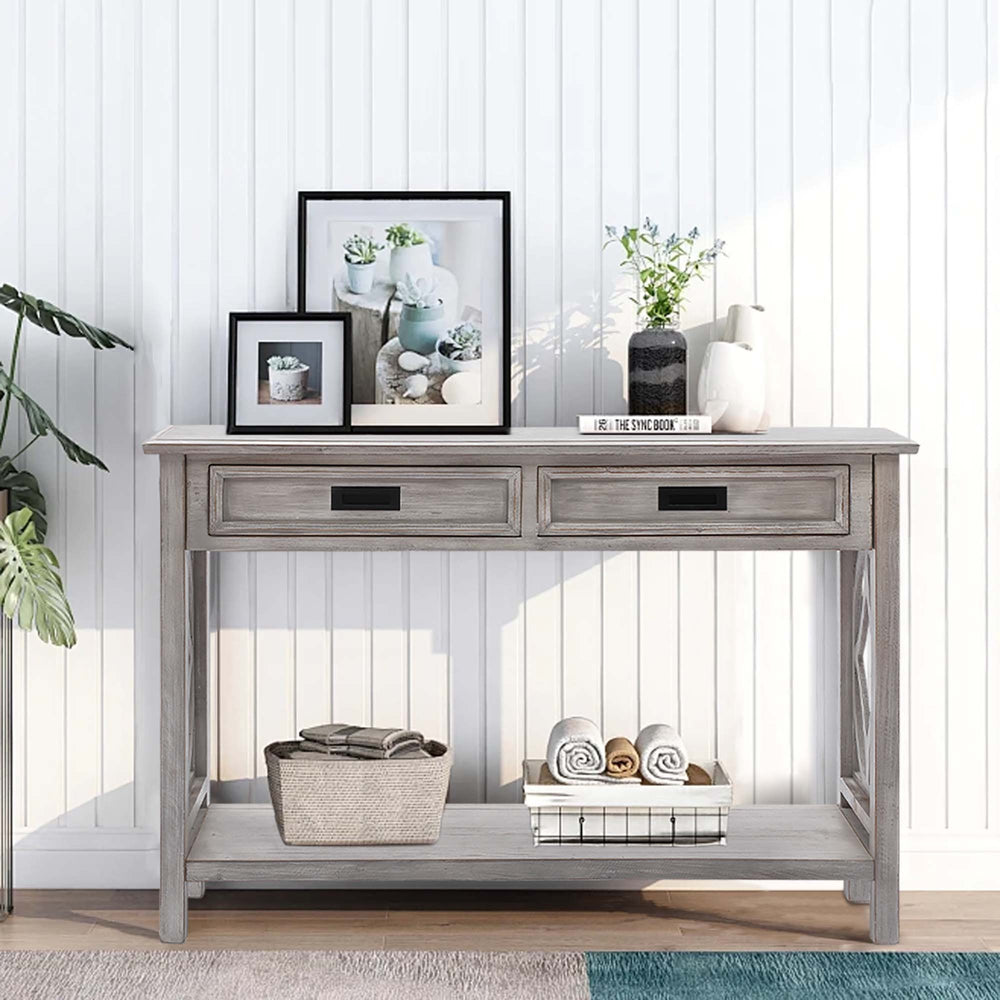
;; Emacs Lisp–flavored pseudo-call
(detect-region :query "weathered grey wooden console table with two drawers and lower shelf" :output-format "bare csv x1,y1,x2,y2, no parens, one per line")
144,426,917,944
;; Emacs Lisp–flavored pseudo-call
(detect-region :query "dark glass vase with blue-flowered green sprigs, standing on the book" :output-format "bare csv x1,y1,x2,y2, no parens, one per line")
604,217,724,416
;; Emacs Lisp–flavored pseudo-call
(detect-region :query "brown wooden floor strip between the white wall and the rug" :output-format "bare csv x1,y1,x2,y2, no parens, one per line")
0,890,1000,951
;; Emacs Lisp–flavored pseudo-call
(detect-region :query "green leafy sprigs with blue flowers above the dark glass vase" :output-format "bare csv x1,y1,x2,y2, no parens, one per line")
604,216,725,327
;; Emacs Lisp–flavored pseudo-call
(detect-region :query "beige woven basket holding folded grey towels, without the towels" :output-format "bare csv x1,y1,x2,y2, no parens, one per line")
264,740,452,845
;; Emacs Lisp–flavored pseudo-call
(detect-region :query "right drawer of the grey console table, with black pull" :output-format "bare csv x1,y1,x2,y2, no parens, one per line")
538,465,850,536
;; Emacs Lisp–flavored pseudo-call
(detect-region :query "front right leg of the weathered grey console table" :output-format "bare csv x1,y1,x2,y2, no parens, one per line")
870,455,899,944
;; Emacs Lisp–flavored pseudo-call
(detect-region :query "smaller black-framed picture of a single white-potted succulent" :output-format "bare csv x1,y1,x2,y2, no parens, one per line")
226,312,351,434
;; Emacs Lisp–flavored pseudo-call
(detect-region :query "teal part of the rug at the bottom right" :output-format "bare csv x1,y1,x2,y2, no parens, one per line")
587,951,1000,1000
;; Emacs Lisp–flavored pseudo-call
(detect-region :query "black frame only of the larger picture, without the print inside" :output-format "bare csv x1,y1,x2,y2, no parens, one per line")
297,191,511,434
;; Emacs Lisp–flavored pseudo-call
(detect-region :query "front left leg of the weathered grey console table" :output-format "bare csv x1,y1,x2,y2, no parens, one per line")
160,455,188,944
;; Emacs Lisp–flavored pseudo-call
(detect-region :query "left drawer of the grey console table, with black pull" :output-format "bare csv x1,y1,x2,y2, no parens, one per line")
208,465,521,536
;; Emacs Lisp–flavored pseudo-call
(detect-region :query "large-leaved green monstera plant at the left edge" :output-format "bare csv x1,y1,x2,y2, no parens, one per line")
0,285,132,646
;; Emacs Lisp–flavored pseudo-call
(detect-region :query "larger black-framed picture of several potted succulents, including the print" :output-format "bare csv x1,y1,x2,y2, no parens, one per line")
298,191,510,434
